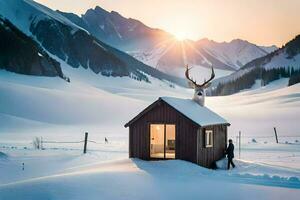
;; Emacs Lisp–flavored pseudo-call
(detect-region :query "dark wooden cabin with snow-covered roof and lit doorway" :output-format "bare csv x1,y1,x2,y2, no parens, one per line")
125,97,230,168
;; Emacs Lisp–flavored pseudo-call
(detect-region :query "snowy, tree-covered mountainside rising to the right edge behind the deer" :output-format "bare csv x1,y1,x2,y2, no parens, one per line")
211,35,300,95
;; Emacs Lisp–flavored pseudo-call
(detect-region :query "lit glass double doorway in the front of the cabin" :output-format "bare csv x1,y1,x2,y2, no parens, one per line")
150,124,176,159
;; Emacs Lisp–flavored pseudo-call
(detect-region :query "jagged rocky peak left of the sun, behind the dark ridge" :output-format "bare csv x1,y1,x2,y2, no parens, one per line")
57,6,173,51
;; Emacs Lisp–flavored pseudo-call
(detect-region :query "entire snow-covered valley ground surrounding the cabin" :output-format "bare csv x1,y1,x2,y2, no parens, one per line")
0,57,300,200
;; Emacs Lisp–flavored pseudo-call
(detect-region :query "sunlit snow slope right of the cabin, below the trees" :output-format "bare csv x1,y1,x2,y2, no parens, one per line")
207,80,300,137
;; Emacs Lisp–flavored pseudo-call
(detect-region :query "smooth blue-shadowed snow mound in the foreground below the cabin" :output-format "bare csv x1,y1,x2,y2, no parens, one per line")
0,156,300,200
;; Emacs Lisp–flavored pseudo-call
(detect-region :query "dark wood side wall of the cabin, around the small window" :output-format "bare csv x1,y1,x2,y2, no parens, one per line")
197,125,227,168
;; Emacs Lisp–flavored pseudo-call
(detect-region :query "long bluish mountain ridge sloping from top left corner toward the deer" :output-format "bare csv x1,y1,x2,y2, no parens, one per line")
0,0,185,84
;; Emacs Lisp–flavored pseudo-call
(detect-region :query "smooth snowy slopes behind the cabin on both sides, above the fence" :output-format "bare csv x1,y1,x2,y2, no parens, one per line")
0,59,300,139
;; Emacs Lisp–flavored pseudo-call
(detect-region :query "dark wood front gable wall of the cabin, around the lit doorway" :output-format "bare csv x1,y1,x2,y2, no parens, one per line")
129,101,199,163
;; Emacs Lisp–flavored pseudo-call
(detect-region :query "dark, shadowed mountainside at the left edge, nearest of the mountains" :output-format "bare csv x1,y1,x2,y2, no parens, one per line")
0,17,65,78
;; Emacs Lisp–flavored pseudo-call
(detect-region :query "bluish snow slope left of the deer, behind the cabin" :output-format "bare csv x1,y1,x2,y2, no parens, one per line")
0,56,190,137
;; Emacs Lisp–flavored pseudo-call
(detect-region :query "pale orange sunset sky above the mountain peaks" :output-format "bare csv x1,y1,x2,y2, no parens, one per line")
37,0,300,47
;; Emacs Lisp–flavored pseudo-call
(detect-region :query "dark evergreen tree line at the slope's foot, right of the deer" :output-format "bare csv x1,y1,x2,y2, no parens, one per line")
207,67,300,96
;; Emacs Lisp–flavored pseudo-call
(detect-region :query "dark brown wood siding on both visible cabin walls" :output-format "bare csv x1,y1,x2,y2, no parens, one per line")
129,101,227,168
